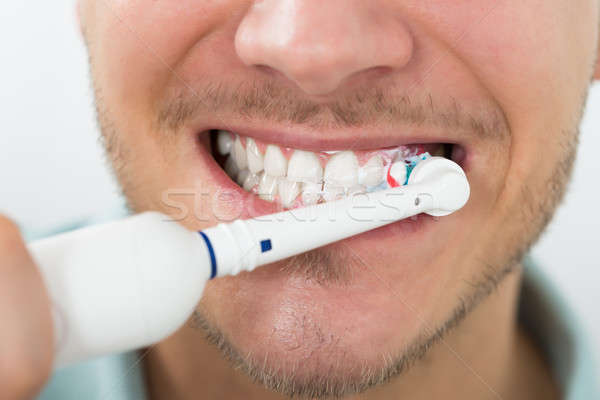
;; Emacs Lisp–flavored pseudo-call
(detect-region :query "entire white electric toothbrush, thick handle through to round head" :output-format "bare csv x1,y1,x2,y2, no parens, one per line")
29,158,469,367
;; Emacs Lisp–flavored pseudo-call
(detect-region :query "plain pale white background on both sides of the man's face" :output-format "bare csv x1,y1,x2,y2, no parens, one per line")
0,0,600,382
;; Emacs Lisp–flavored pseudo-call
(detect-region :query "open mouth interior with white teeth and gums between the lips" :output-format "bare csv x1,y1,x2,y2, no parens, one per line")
207,129,466,209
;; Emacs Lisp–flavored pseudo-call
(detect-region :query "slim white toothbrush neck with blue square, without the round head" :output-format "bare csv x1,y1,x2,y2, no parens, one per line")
203,179,433,276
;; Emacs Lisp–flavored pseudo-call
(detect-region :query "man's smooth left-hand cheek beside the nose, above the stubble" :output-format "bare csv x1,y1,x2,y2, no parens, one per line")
87,0,235,135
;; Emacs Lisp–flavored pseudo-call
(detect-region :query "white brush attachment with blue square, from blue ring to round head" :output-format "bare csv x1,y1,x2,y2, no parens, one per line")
203,157,470,276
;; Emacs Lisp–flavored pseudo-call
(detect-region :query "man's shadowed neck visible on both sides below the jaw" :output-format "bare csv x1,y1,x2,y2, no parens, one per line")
146,266,558,400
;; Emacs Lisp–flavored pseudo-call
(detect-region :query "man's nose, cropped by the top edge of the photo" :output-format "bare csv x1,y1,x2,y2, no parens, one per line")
235,0,413,95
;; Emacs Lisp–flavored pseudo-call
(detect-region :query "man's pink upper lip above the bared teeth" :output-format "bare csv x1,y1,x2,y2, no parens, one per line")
194,121,466,152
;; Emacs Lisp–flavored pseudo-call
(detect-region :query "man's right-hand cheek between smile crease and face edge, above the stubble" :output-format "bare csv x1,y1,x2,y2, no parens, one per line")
452,0,598,173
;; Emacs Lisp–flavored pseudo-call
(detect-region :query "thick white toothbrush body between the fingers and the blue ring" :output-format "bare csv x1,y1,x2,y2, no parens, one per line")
28,212,210,368
